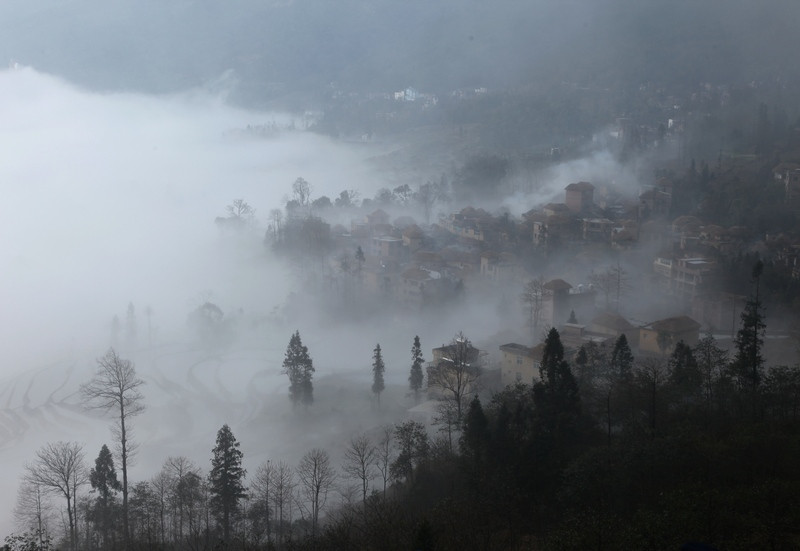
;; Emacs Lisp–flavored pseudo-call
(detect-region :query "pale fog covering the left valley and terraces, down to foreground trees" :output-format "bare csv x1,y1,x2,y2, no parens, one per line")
0,68,424,529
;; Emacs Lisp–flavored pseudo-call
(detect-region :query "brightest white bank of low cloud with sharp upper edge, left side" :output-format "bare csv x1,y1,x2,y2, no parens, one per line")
0,69,386,374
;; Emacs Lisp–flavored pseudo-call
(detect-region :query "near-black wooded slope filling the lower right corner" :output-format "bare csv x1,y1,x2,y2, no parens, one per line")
304,330,800,549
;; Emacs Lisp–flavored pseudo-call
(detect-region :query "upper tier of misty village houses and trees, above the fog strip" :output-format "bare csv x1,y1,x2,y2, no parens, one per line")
322,178,760,320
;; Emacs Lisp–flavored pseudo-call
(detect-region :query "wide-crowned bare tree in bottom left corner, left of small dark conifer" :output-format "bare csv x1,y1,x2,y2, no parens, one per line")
25,441,89,551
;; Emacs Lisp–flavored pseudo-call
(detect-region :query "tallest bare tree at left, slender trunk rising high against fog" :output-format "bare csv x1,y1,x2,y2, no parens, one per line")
81,348,144,545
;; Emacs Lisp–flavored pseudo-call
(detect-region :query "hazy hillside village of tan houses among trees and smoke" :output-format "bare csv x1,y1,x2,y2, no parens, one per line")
268,163,800,385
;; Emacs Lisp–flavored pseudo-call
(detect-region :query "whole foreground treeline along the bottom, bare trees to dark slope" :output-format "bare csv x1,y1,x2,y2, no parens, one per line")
6,304,800,550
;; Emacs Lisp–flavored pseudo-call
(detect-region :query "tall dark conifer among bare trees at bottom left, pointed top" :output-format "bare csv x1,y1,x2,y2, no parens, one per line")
208,425,247,542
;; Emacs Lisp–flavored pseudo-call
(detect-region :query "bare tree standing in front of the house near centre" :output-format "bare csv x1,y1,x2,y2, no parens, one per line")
428,332,480,423
